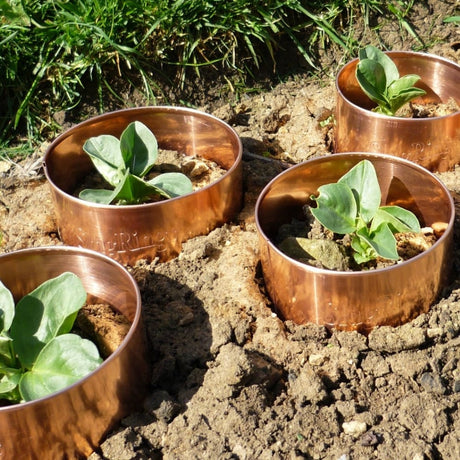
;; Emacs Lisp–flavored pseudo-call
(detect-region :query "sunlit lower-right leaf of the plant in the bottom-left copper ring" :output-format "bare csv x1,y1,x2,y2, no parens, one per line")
19,334,102,401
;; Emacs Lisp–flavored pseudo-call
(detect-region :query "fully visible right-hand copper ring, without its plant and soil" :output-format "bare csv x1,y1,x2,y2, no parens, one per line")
255,153,455,332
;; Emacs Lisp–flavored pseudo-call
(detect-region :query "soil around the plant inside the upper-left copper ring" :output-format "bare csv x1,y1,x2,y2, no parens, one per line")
73,149,227,203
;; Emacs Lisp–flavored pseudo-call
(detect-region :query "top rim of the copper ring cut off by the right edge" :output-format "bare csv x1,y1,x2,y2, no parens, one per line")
335,51,460,120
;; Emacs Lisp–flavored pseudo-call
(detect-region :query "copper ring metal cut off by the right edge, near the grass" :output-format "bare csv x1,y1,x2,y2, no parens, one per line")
334,52,460,171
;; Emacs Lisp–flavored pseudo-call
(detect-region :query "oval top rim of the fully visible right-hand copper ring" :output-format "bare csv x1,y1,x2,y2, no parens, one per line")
255,152,455,277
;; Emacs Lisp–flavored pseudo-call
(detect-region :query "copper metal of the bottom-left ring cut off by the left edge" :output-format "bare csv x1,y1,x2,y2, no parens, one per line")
0,246,150,460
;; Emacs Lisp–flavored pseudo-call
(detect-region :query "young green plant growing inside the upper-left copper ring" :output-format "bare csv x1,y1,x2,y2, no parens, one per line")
79,121,192,204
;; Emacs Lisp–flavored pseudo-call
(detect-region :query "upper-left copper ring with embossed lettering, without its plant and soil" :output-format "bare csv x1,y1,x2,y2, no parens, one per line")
44,107,242,264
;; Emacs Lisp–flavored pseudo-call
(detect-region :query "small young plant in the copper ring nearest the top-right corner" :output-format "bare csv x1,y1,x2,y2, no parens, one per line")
356,45,426,116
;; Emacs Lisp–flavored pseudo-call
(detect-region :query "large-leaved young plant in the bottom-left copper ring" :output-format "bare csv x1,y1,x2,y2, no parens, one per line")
0,272,102,403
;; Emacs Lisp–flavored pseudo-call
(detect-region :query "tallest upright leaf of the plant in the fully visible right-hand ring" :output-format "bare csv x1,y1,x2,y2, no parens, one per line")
338,160,381,224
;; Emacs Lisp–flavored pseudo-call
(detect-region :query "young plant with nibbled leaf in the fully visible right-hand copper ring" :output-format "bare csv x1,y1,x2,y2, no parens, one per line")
311,160,420,264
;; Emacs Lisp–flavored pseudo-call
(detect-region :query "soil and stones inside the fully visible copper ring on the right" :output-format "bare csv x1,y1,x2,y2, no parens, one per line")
275,206,438,271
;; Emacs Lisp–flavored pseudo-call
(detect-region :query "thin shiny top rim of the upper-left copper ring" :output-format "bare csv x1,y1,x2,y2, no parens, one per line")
43,105,243,210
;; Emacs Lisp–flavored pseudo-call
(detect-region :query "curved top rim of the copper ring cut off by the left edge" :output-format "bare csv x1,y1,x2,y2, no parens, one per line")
0,246,142,413
